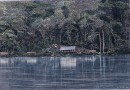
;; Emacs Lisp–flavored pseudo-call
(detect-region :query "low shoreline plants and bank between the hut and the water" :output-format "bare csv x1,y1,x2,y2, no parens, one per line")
0,46,130,57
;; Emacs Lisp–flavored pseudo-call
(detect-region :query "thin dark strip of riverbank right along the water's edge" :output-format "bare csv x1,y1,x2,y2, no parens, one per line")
0,52,130,57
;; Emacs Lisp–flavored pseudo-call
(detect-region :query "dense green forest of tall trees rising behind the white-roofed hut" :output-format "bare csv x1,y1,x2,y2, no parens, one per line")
0,0,130,54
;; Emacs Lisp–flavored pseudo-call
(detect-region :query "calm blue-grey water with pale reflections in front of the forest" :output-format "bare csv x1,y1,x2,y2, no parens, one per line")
0,55,130,90
